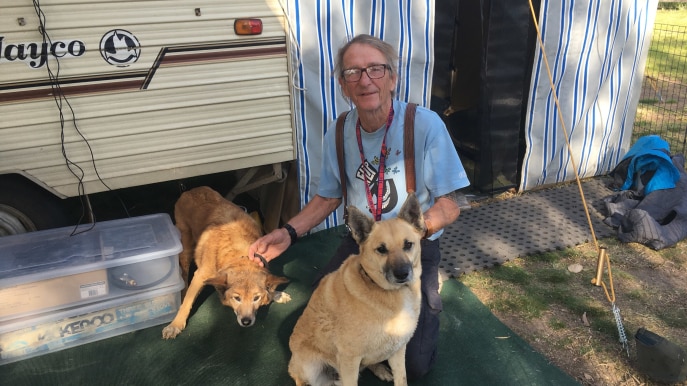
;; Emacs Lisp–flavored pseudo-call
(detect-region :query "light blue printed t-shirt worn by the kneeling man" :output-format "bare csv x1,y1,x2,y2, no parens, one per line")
318,100,470,239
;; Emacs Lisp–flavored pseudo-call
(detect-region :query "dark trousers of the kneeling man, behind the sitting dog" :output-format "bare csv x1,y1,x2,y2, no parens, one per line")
313,235,442,379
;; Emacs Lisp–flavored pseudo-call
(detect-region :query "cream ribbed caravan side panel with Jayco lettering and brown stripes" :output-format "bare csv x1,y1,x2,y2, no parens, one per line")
0,0,295,196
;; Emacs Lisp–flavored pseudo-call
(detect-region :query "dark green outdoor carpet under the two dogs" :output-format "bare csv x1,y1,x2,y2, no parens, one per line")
0,228,577,386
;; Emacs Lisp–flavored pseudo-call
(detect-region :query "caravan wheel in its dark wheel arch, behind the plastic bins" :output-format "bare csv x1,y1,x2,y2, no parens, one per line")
0,175,68,237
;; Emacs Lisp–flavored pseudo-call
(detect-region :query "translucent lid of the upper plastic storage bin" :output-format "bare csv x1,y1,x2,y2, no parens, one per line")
0,213,182,288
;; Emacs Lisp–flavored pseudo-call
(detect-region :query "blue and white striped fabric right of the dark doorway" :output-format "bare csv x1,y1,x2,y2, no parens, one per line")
520,0,657,190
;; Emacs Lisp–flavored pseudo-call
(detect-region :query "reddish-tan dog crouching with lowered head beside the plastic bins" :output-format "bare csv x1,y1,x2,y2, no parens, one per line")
162,186,291,339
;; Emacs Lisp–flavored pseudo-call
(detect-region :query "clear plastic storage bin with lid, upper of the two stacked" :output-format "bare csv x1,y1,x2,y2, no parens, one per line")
0,214,183,323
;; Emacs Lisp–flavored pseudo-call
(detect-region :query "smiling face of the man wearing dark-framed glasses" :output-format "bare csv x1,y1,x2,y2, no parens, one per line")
339,43,396,112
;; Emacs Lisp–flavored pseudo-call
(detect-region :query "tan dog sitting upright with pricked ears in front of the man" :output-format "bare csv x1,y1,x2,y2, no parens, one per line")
289,194,425,386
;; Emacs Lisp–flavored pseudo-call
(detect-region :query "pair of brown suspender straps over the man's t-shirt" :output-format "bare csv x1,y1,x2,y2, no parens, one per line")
336,103,417,224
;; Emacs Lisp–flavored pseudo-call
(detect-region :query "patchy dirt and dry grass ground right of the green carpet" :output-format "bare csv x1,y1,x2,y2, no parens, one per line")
460,234,687,385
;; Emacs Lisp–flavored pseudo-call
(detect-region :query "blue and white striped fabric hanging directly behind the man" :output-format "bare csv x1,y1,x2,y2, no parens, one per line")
282,0,434,230
